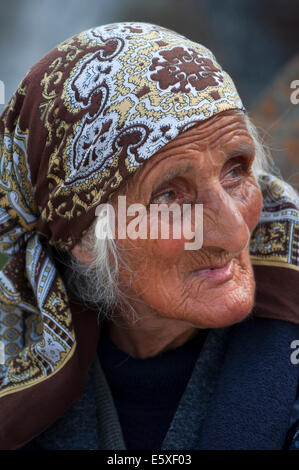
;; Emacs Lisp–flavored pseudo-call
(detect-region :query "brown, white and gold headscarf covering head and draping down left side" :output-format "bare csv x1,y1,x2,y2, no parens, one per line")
0,23,298,447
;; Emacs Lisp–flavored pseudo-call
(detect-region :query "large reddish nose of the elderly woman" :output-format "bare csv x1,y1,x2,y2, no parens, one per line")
203,187,250,253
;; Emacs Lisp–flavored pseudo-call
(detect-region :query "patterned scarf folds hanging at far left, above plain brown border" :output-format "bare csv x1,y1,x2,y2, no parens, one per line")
0,126,75,397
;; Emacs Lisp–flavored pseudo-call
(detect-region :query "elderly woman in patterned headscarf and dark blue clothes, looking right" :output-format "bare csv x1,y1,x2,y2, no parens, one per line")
0,23,299,449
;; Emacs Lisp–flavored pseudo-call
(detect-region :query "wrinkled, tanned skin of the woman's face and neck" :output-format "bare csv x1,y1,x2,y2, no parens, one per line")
73,112,262,357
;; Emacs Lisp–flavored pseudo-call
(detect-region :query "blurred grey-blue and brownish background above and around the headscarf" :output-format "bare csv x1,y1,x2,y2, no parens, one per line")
0,0,299,182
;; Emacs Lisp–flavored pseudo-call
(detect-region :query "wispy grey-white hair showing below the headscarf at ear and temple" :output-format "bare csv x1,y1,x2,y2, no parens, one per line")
67,111,276,320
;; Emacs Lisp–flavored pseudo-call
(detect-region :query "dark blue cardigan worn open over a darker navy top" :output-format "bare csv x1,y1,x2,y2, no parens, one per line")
19,318,299,450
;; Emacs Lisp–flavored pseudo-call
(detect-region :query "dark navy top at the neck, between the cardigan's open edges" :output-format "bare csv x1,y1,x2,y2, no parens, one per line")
98,330,207,449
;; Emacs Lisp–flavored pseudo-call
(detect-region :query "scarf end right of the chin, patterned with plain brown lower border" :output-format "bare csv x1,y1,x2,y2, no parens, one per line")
250,173,299,323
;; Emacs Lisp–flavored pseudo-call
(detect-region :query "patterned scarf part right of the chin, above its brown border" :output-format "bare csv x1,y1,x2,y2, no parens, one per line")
250,174,299,270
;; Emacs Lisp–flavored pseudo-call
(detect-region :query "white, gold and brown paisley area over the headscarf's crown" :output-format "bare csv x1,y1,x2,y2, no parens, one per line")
36,24,242,244
